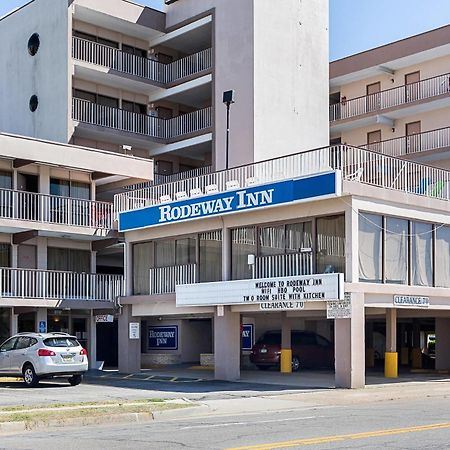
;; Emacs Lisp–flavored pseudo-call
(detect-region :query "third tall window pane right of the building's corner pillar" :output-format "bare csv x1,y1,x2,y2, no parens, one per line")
411,222,434,286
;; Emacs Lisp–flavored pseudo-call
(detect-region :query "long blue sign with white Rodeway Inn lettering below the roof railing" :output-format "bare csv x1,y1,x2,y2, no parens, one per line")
119,172,341,232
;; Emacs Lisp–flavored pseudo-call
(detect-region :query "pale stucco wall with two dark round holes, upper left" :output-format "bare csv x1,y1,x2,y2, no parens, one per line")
0,0,69,142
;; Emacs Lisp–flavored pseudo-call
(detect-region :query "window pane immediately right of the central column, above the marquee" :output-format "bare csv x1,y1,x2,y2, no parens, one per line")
231,227,257,280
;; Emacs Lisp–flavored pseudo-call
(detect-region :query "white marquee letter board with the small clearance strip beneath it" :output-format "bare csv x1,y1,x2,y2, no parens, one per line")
175,273,344,311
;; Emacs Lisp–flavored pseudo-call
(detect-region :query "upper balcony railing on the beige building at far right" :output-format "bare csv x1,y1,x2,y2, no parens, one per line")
330,73,450,122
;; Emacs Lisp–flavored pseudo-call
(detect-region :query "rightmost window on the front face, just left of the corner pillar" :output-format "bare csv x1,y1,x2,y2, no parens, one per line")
316,216,345,273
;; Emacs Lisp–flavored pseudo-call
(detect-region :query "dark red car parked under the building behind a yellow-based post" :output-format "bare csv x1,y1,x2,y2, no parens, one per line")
250,330,334,372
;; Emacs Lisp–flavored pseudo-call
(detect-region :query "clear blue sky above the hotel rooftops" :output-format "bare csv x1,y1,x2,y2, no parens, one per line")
0,0,450,61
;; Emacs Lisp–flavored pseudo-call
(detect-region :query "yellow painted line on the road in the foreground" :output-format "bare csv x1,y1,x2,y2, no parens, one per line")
228,422,450,450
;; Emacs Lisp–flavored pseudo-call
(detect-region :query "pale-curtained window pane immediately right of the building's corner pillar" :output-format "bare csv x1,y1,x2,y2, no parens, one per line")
359,214,383,283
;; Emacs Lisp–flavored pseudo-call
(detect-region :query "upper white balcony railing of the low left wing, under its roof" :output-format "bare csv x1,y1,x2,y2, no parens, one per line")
0,189,113,230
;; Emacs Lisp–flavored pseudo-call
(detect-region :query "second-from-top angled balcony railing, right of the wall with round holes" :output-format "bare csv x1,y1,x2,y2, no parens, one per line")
72,98,211,140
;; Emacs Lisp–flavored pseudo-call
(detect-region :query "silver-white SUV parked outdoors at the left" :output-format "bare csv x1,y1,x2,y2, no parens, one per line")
0,333,88,387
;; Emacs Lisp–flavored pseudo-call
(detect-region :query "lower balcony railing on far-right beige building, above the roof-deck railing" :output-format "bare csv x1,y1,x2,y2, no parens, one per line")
358,127,450,157
